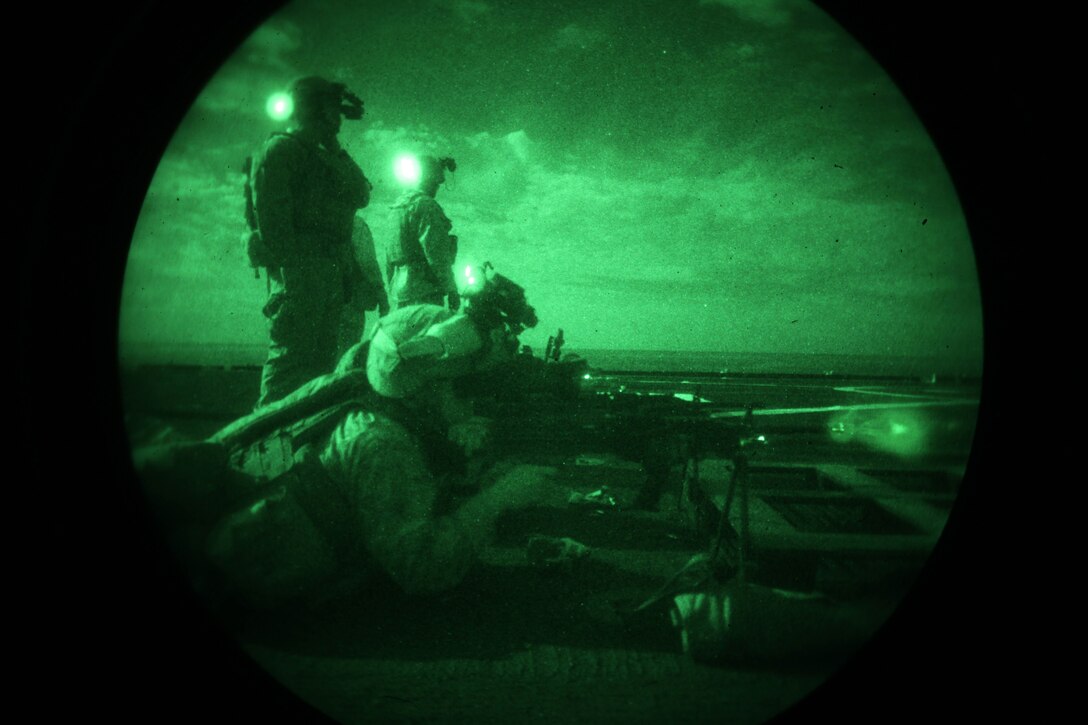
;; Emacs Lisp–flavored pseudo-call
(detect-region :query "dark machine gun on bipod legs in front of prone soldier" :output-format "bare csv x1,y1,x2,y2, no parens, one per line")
478,335,767,580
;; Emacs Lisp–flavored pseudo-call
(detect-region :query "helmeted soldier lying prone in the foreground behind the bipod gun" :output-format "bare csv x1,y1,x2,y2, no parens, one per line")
135,306,544,613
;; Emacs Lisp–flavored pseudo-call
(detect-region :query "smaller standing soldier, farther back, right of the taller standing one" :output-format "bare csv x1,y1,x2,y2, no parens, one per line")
385,156,461,310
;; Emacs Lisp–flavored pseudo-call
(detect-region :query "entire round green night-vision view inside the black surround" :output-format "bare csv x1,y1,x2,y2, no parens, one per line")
119,0,982,723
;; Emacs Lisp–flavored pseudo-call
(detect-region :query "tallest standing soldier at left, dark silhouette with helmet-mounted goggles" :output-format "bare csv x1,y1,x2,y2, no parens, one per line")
250,76,371,407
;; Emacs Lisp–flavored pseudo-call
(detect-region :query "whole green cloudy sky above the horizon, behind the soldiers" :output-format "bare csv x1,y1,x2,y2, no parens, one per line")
121,0,982,366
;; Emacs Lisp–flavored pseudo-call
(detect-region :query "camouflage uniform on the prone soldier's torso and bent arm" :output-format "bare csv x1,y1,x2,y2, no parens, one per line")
207,389,486,609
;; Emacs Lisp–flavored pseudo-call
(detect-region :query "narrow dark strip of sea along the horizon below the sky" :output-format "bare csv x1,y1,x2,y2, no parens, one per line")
119,343,982,380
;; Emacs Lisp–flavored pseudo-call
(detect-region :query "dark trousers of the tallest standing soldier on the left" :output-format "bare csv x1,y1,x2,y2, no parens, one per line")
257,261,345,407
